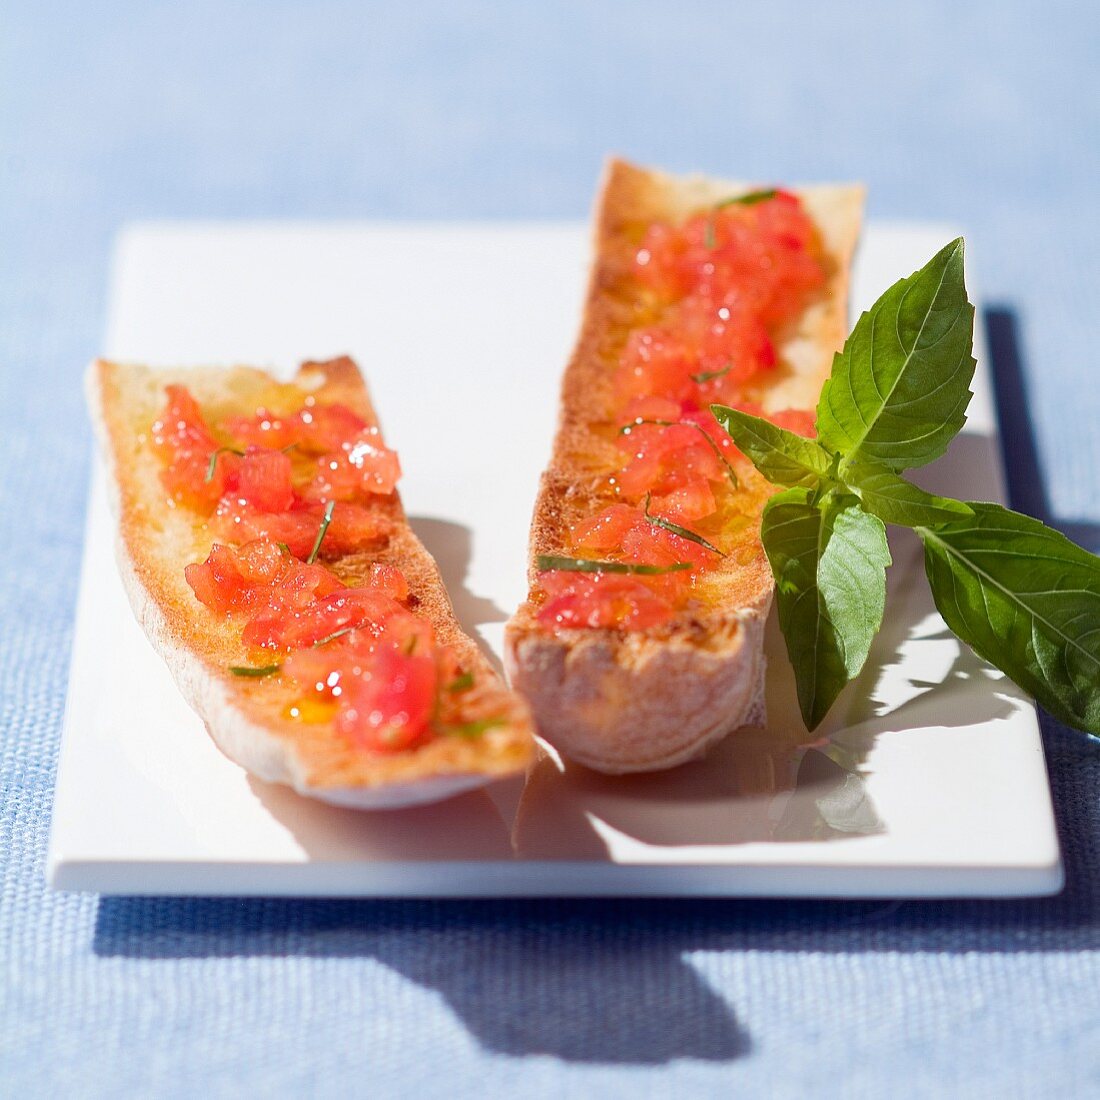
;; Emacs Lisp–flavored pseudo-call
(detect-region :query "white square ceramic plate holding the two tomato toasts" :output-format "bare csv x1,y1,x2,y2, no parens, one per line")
48,223,1062,897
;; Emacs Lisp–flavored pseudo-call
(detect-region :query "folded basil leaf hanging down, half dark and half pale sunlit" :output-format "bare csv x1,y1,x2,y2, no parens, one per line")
761,487,890,729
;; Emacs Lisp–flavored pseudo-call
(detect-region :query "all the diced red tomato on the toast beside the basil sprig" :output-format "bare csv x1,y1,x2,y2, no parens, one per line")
538,190,826,629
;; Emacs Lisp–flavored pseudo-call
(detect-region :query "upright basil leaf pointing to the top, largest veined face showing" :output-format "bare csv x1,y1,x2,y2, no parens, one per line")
817,238,975,471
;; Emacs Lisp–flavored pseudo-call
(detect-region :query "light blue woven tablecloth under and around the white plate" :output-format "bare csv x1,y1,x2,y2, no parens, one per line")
0,0,1100,1098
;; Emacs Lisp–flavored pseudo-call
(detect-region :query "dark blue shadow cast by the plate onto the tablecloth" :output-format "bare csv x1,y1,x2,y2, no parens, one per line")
94,309,1100,1065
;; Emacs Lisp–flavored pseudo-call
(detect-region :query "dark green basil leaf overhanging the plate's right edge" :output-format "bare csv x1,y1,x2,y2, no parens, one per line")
917,504,1100,734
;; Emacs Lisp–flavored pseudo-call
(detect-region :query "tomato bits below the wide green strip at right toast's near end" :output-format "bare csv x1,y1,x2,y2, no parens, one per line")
538,570,673,630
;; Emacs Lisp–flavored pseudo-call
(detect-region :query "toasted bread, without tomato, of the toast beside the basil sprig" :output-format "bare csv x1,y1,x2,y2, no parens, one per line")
505,161,864,773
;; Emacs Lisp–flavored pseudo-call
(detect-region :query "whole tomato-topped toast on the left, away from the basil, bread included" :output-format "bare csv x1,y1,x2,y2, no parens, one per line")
88,359,532,809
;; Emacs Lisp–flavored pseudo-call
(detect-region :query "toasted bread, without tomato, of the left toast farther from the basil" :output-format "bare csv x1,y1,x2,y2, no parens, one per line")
88,359,534,810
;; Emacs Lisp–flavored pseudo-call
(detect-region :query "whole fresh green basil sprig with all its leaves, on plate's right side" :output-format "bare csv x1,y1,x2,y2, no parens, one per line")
712,239,1100,734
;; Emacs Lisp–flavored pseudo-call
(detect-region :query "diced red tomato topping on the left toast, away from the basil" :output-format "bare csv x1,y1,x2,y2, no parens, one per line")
153,386,495,752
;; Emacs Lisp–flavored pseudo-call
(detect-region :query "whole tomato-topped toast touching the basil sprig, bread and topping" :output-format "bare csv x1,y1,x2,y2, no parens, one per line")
505,161,862,773
